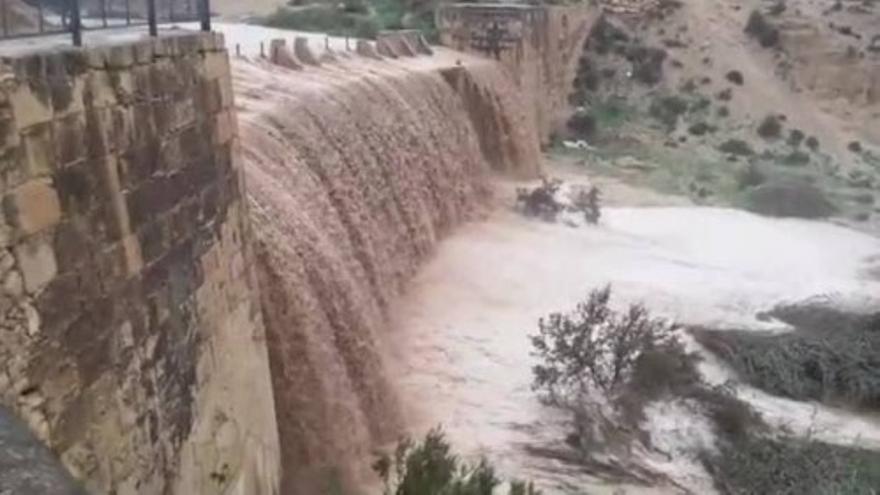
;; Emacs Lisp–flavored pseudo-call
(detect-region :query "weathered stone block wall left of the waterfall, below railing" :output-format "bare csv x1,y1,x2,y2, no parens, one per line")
0,34,279,494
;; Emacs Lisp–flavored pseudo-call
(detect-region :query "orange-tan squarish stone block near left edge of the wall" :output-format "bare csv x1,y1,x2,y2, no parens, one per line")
3,179,61,235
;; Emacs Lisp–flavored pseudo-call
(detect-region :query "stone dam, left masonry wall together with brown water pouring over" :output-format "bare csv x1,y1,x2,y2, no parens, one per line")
0,10,596,494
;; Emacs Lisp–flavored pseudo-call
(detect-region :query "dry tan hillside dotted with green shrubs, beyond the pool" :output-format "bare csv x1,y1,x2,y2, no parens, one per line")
562,0,880,228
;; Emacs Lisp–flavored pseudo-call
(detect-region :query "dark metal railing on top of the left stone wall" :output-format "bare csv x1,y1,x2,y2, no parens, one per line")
0,0,211,46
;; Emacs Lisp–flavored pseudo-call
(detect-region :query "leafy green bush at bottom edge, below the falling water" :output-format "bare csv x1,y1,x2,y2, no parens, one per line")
373,428,540,495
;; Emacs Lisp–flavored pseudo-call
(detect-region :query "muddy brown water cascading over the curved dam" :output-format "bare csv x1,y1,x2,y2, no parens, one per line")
234,50,540,493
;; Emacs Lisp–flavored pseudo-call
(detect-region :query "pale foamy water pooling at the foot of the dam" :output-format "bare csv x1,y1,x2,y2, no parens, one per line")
392,203,880,493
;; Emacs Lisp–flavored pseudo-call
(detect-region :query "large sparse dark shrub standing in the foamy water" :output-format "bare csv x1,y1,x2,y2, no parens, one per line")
530,286,764,455
